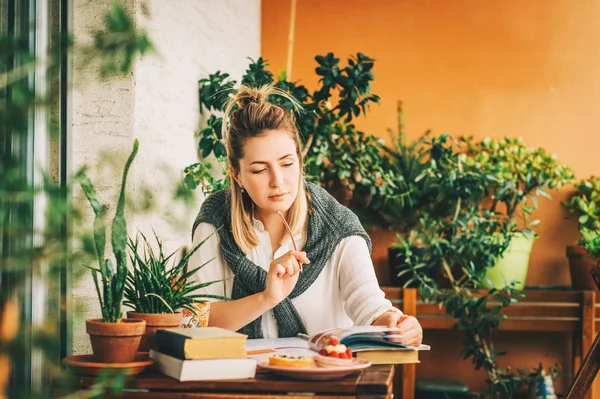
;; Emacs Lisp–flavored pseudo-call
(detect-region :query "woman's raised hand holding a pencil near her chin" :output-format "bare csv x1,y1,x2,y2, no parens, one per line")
263,250,310,307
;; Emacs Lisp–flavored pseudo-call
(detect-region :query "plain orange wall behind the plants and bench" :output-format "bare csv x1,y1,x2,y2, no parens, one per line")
262,0,600,392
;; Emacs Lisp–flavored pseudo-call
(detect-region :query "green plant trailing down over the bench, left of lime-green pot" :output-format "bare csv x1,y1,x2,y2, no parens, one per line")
396,135,524,397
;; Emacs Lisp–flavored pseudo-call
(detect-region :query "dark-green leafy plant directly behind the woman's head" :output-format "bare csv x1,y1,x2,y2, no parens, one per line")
185,53,401,223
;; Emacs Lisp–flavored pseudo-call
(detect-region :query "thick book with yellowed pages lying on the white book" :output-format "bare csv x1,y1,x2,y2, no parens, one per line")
155,327,248,360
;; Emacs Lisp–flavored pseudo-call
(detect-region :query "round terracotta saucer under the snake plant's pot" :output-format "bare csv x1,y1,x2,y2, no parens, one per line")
63,352,154,375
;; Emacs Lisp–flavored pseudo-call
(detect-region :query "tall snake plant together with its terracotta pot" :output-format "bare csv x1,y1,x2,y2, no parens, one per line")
77,139,146,363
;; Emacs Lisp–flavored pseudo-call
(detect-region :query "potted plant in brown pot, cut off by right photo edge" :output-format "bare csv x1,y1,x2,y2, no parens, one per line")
562,176,600,290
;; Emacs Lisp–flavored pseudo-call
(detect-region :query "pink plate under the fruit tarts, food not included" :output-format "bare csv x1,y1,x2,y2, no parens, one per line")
258,358,371,380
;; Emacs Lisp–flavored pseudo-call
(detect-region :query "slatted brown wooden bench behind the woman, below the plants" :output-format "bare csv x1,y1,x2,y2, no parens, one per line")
382,287,600,399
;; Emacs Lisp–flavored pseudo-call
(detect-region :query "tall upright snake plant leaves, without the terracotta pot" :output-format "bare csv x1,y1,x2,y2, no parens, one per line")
77,139,139,323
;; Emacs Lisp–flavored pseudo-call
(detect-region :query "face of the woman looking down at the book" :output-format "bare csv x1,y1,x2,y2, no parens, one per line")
234,130,300,217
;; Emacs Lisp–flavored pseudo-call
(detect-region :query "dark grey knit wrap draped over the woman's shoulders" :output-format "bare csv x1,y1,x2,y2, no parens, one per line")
192,183,371,338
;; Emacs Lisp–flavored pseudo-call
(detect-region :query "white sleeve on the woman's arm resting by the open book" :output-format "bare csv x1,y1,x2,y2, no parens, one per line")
336,236,401,326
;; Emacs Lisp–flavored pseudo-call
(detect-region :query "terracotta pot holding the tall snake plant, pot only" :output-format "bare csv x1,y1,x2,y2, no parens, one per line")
85,319,146,363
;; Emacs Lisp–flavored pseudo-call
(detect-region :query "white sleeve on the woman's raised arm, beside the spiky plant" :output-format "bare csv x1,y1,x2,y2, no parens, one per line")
188,223,233,301
